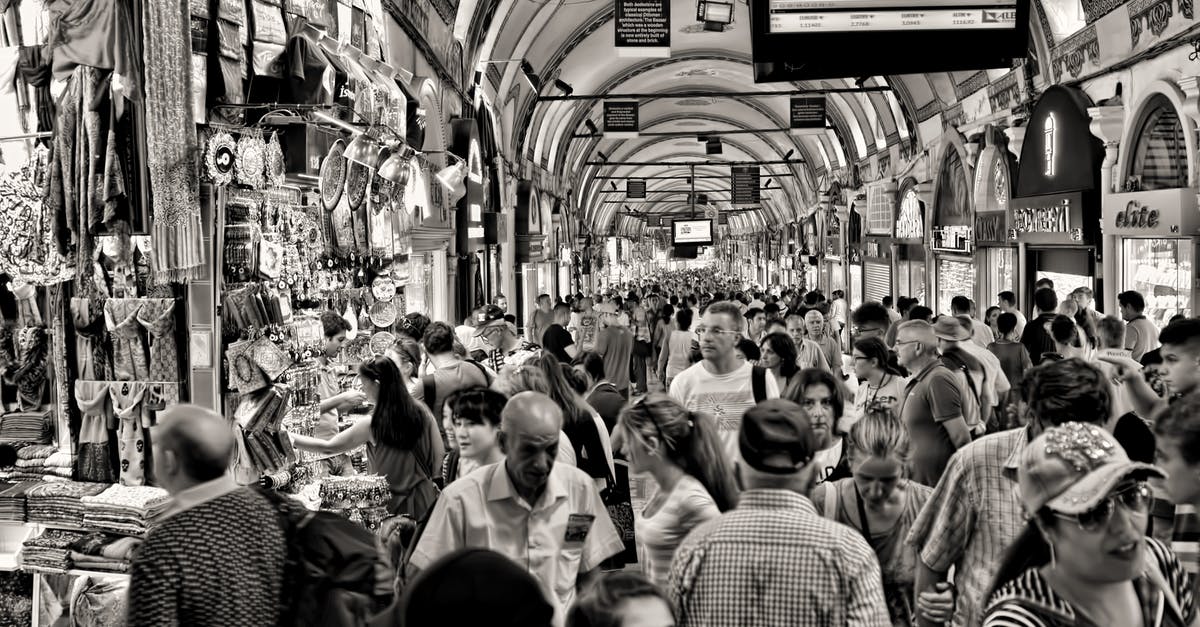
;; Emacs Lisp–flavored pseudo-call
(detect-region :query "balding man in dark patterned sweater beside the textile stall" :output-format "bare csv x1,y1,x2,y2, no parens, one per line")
127,405,287,626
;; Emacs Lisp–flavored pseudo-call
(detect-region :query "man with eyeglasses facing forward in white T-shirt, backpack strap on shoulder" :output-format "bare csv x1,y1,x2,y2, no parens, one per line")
671,301,779,460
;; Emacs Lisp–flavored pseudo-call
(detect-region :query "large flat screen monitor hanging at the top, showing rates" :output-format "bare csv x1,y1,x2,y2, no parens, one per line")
750,0,1030,83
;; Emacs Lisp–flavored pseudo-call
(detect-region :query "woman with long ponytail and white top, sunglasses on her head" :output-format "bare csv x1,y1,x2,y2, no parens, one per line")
613,393,737,585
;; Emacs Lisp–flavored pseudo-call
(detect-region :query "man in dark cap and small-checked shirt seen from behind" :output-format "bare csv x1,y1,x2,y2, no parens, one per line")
667,399,890,627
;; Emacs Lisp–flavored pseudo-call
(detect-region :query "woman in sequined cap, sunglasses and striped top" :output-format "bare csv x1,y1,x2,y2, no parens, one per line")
984,423,1196,627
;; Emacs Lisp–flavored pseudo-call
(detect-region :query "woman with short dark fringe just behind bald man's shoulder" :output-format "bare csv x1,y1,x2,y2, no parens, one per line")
442,388,509,489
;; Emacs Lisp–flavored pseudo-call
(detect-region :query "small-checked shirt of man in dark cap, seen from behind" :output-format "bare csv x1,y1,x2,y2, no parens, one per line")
667,490,892,627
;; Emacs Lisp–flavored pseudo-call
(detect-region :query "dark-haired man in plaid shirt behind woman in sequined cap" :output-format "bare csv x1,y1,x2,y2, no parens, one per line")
898,355,1111,627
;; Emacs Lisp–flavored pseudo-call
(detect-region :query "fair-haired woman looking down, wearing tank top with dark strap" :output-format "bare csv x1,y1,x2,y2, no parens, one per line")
811,408,934,626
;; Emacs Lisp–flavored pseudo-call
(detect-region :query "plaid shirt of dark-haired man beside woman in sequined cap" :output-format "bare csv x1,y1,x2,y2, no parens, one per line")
908,428,1028,627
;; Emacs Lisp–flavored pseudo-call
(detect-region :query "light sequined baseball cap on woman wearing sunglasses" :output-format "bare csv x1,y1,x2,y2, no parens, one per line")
1016,423,1165,516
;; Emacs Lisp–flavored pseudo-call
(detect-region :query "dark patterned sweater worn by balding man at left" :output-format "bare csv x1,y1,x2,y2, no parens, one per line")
127,488,287,627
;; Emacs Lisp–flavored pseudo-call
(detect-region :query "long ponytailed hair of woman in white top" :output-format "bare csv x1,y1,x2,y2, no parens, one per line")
618,393,738,512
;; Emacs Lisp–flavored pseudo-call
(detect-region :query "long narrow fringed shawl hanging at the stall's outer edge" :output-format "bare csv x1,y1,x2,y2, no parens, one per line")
143,0,205,282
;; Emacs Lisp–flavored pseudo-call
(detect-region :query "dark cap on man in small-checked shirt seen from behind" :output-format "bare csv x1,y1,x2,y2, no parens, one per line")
738,399,816,474
